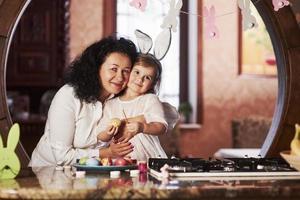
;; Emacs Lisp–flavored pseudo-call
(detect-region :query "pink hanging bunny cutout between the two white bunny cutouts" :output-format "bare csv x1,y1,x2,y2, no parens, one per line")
203,6,219,39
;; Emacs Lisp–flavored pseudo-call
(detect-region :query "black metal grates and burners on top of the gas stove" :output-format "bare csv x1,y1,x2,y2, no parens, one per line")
148,158,295,173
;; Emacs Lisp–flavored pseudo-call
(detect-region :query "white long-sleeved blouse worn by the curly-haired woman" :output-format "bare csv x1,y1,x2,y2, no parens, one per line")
29,85,108,167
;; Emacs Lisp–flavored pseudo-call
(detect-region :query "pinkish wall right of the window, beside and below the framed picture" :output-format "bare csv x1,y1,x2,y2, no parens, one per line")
178,0,277,157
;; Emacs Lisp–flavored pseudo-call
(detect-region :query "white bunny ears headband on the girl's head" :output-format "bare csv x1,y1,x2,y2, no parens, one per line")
134,28,172,60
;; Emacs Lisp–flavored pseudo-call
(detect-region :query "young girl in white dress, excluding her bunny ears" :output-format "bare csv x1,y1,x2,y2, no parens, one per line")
98,54,168,161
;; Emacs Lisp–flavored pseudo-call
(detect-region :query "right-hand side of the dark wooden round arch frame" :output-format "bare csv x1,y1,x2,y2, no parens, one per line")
252,0,300,157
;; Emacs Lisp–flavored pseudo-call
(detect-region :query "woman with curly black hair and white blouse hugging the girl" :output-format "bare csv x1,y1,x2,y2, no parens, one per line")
29,37,137,167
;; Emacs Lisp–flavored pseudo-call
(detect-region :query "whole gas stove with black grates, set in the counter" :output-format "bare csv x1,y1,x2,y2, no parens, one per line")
148,158,300,180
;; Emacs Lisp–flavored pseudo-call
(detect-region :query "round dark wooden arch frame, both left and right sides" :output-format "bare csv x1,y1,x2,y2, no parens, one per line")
0,0,300,167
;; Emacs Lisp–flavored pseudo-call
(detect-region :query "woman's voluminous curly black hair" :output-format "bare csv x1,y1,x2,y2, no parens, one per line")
64,36,137,103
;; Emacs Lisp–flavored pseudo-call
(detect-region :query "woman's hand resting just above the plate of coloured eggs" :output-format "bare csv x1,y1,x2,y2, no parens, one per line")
108,142,133,158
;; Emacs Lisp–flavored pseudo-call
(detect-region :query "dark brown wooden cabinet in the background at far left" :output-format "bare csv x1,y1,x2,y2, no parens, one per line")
7,0,68,88
